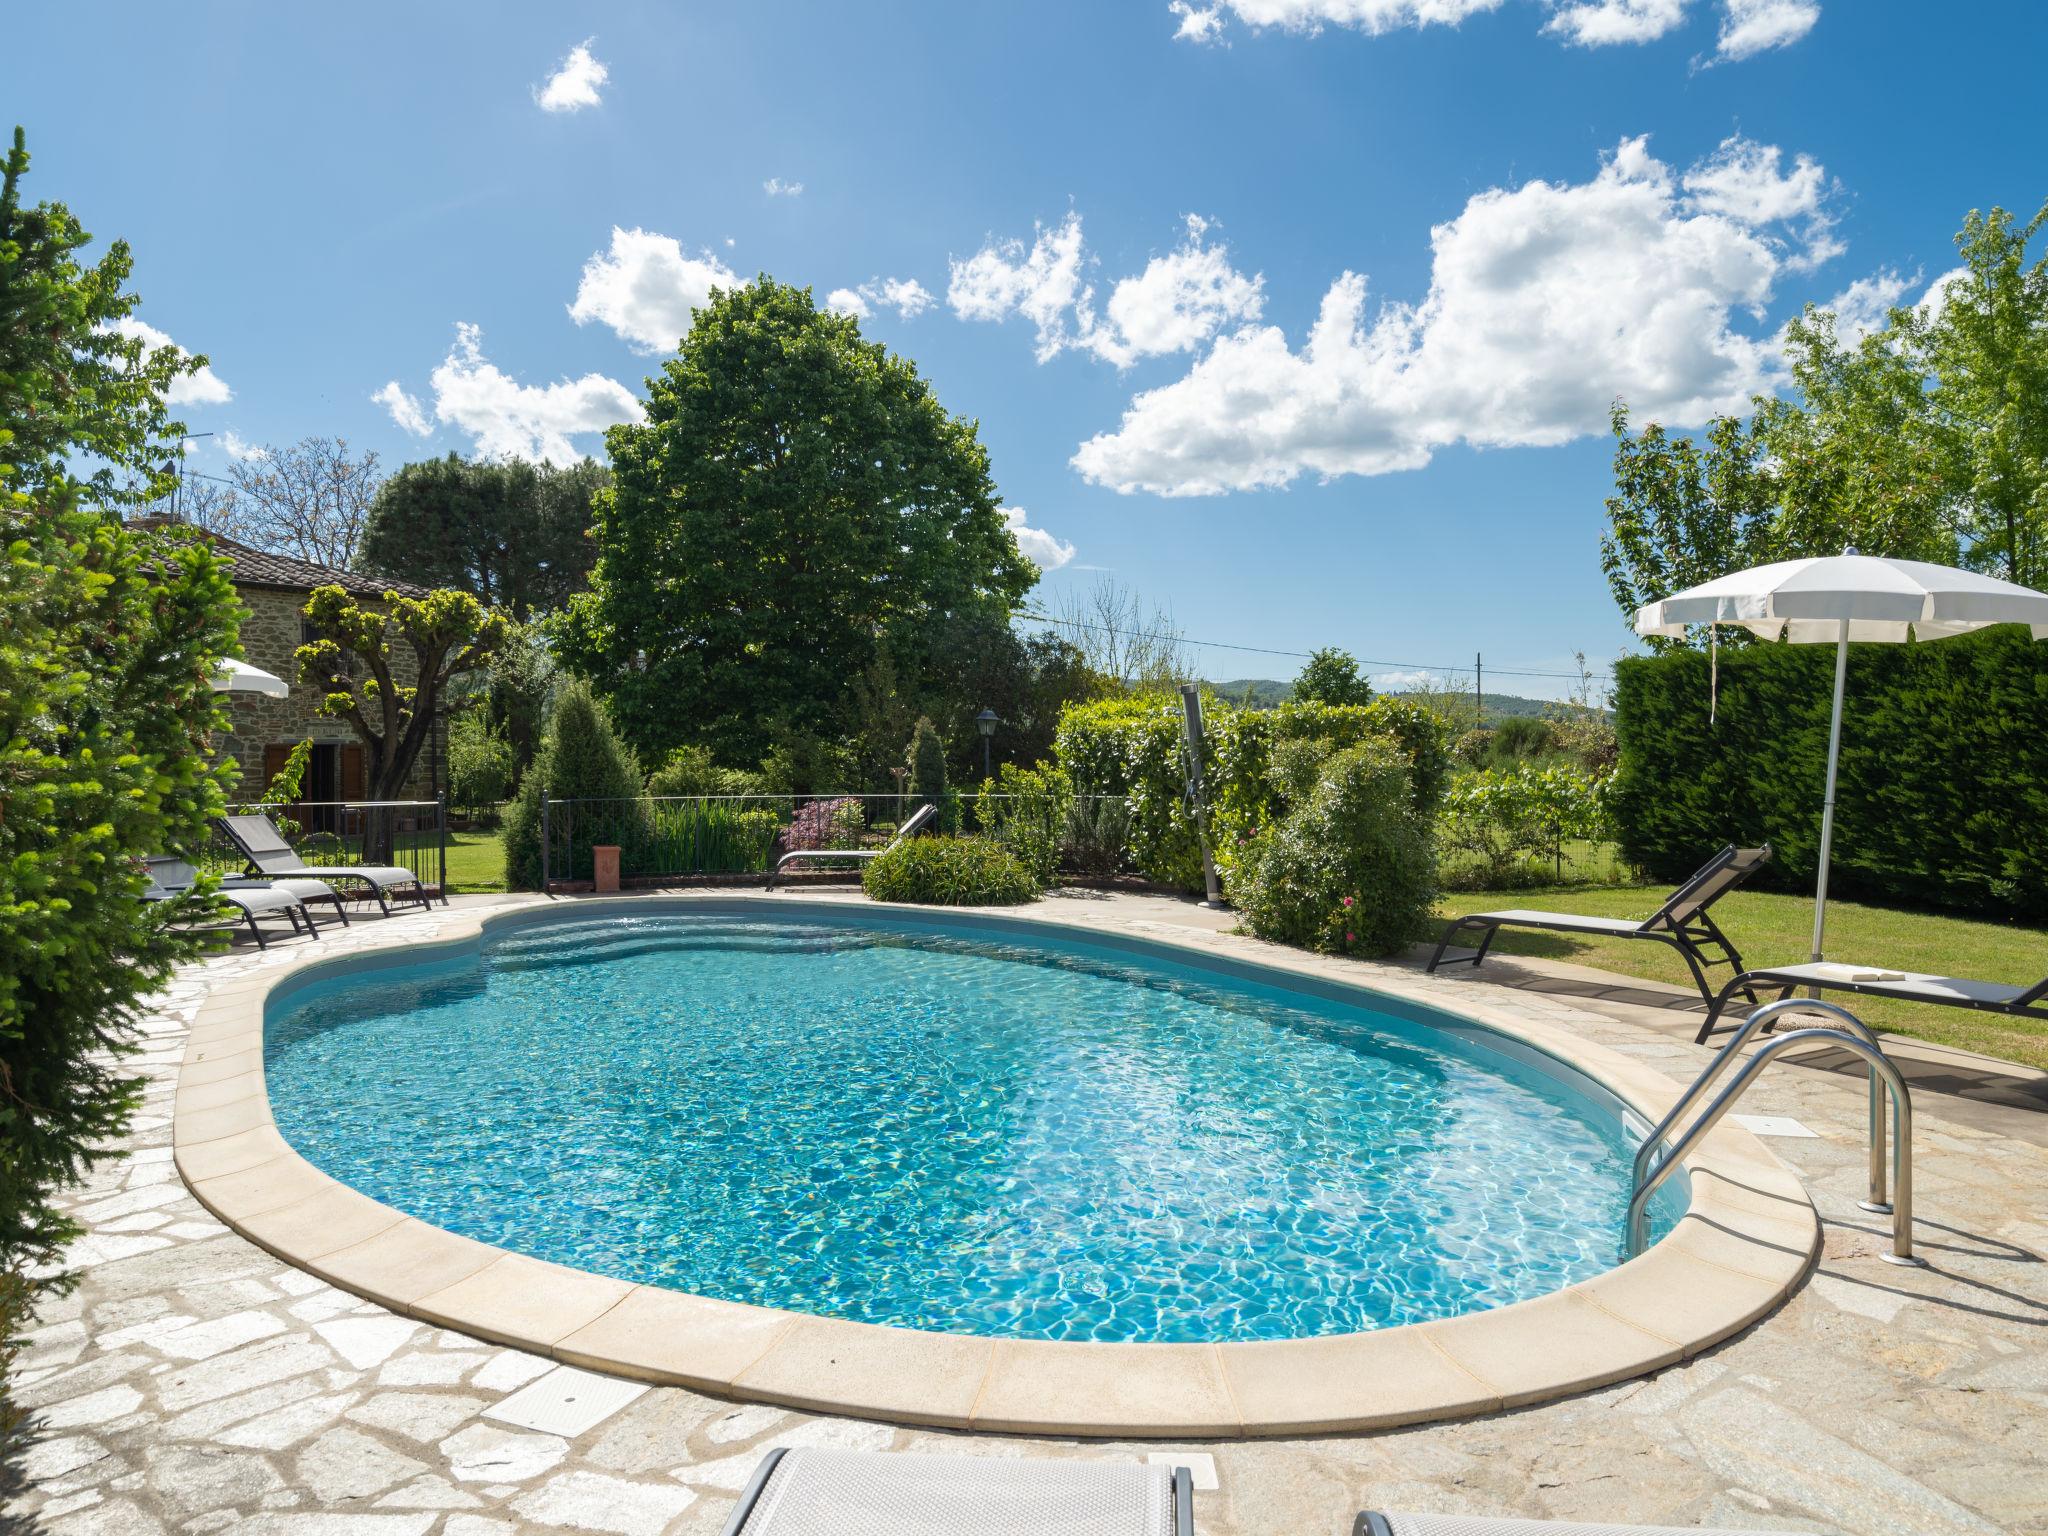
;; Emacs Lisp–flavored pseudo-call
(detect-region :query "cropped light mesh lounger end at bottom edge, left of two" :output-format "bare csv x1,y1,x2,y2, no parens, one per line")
725,1448,1194,1536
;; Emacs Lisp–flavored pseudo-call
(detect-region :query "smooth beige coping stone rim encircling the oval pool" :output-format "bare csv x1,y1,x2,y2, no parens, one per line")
172,889,1821,1438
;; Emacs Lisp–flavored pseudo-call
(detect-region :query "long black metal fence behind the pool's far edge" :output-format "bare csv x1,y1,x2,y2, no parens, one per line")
541,793,1128,887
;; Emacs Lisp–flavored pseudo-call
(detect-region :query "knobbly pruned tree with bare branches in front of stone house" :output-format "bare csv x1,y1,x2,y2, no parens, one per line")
299,586,510,860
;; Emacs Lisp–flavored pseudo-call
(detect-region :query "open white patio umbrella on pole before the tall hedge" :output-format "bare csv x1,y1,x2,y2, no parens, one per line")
1636,549,2048,961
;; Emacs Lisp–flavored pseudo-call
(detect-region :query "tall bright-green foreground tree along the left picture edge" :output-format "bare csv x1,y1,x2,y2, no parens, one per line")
0,129,240,1310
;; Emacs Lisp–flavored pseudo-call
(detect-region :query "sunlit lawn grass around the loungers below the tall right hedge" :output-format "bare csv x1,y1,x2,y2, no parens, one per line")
1438,885,2048,1071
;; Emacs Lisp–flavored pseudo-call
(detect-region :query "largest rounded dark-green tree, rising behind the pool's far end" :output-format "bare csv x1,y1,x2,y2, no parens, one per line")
559,276,1036,764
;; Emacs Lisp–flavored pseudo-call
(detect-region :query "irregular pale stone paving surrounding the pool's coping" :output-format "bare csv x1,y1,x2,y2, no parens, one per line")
8,899,2048,1536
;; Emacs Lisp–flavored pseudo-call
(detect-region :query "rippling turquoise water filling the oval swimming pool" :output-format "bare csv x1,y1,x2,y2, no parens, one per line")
264,909,1683,1339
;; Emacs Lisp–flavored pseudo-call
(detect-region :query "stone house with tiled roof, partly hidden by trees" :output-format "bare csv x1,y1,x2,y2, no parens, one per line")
195,535,446,823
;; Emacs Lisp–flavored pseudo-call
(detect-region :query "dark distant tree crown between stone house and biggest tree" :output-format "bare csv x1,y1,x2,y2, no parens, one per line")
358,453,610,623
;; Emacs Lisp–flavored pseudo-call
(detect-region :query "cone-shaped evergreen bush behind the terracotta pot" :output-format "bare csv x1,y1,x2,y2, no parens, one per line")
504,680,653,891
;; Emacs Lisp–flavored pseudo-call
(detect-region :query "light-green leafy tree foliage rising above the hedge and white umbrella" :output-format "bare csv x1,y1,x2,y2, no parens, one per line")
1602,207,2048,643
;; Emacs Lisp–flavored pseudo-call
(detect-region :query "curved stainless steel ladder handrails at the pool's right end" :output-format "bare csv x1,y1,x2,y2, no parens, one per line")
1628,997,1925,1266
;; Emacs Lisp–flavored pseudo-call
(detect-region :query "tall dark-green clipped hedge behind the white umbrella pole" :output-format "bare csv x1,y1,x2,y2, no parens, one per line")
1608,629,2048,918
